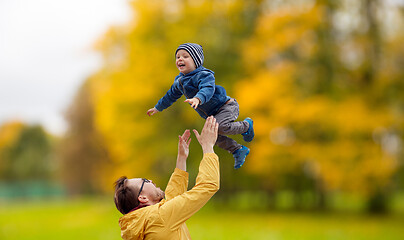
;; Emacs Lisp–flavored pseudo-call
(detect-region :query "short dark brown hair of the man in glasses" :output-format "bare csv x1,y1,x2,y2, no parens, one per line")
114,176,139,214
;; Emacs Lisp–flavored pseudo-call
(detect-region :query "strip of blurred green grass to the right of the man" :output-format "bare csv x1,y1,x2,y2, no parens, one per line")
188,212,404,240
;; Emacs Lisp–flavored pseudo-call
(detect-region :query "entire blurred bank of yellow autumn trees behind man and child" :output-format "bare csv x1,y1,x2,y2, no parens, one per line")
83,0,403,212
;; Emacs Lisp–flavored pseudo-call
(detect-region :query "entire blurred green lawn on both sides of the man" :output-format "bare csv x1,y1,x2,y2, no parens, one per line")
0,199,404,240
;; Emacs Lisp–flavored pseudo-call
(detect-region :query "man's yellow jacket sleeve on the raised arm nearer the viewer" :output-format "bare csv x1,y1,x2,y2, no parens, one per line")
160,153,220,230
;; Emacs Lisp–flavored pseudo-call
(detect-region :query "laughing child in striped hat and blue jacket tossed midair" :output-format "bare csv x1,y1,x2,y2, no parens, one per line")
147,43,254,169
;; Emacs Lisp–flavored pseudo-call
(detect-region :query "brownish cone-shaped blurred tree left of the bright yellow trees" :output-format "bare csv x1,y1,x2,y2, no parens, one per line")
57,82,112,195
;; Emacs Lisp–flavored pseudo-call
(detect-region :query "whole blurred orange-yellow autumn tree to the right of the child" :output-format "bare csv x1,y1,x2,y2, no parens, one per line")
238,1,402,211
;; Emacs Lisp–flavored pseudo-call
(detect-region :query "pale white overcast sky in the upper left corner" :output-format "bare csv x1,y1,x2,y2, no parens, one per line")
0,0,131,135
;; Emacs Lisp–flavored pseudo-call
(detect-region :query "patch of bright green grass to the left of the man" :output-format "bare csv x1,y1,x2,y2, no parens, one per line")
0,199,120,240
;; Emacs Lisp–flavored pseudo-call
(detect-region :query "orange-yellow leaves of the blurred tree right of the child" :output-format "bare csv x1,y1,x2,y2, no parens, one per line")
236,0,400,194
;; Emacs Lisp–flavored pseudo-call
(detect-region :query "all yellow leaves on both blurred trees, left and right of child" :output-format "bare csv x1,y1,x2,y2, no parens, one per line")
85,0,402,198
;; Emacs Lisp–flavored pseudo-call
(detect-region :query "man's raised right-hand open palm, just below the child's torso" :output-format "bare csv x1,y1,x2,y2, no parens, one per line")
193,116,219,153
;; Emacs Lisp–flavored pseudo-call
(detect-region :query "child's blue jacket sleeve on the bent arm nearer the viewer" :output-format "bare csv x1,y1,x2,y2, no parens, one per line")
194,71,215,105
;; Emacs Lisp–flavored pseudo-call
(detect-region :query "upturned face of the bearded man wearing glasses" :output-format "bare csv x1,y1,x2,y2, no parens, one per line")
127,178,165,204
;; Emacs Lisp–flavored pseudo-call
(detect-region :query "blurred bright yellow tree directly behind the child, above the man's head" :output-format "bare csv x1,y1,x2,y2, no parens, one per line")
91,0,263,189
